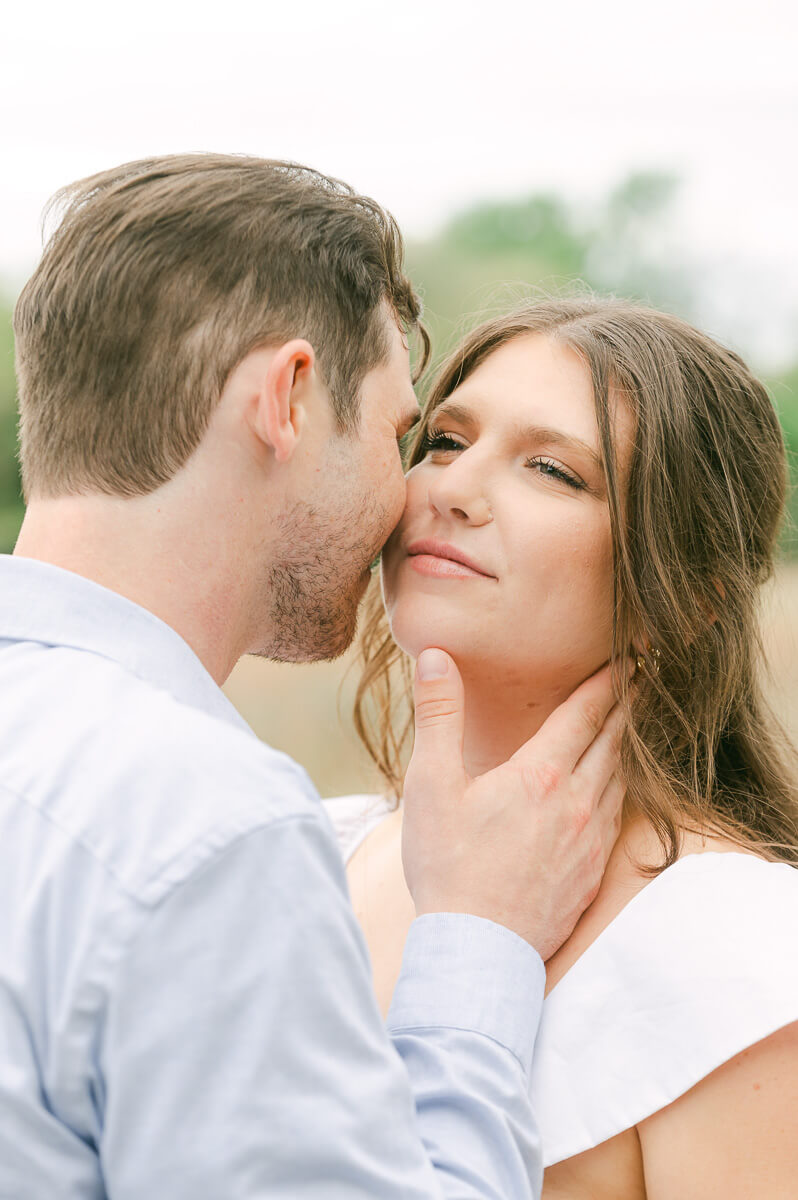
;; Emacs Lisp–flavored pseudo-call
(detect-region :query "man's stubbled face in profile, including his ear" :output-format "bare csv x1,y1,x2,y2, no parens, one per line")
244,316,419,662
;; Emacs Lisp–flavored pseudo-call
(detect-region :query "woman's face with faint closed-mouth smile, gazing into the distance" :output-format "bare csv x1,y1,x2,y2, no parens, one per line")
383,334,631,694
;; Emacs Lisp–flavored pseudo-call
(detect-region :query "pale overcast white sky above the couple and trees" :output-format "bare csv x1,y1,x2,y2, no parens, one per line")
0,0,798,359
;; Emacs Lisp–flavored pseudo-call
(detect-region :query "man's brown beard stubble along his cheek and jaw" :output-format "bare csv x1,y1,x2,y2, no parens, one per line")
256,502,390,662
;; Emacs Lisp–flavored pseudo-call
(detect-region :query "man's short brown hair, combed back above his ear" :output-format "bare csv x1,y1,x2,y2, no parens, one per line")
14,154,420,496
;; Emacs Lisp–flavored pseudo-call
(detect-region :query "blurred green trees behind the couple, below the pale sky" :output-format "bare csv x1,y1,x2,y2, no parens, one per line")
0,172,798,558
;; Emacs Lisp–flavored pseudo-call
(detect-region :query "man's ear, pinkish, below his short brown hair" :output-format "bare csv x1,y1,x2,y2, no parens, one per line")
252,337,316,462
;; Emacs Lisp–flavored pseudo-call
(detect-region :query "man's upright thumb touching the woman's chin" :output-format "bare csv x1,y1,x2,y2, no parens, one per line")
404,649,464,797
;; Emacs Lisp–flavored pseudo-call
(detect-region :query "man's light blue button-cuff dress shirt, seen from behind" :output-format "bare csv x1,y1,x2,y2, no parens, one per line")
0,556,544,1200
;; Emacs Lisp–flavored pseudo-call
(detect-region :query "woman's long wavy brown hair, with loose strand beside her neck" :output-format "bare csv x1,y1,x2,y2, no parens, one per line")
355,296,798,869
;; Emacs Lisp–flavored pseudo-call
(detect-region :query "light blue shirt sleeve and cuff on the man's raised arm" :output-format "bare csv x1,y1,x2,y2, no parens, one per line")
97,816,542,1200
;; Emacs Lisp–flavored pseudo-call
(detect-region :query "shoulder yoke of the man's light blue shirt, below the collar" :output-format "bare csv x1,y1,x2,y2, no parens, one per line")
0,650,324,904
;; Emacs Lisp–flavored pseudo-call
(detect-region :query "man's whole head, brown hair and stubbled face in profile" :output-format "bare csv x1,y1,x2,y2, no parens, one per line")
14,155,420,658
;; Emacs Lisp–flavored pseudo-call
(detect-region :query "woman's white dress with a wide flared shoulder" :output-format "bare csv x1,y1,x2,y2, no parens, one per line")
324,796,798,1166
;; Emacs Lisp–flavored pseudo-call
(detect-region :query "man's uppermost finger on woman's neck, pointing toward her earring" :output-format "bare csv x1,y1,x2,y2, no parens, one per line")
512,666,616,772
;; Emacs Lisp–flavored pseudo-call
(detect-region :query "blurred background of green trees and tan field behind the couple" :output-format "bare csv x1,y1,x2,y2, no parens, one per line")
0,173,798,794
